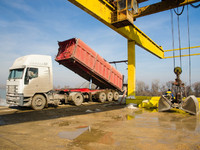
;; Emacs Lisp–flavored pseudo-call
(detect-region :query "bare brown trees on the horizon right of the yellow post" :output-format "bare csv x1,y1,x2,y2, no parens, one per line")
136,80,200,97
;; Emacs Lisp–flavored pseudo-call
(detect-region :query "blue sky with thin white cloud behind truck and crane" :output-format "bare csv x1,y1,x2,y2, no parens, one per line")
0,0,200,87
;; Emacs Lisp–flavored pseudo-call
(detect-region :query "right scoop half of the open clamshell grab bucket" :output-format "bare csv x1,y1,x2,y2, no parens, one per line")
179,95,199,115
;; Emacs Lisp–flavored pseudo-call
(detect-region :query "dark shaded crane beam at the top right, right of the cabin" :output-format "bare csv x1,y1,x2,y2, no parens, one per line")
134,0,200,18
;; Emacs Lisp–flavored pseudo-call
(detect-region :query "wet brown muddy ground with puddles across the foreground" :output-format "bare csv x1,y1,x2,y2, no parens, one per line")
0,102,200,150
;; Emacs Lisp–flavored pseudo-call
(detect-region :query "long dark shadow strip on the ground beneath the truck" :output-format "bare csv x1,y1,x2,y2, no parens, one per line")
0,103,124,126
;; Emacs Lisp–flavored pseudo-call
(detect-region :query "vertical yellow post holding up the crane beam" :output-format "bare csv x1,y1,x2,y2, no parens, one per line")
127,40,136,99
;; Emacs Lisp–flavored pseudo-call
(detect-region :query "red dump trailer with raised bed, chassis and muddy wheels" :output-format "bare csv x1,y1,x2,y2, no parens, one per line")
55,38,123,105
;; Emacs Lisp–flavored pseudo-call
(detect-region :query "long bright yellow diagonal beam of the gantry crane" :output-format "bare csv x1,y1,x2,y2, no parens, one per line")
68,0,164,58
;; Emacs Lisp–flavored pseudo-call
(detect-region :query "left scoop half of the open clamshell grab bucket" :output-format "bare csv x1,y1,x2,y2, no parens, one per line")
158,95,172,112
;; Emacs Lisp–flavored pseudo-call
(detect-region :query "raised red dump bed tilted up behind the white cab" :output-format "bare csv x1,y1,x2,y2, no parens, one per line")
55,38,123,91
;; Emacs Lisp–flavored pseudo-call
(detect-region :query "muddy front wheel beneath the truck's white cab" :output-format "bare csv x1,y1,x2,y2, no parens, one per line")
31,94,46,110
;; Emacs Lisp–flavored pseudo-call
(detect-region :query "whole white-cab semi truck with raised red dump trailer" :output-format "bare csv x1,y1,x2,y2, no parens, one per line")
6,38,123,110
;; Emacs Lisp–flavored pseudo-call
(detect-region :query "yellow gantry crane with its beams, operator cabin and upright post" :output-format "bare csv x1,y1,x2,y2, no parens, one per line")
68,0,200,101
